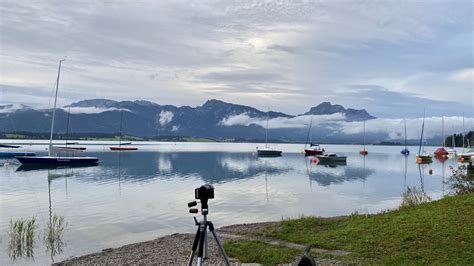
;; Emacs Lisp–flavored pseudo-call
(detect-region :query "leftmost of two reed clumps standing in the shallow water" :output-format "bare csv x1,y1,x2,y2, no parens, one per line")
8,217,38,260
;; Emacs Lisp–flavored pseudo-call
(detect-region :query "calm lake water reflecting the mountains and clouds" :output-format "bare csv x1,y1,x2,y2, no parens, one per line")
0,141,464,265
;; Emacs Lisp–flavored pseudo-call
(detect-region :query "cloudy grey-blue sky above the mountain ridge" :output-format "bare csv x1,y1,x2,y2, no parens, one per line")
0,0,474,119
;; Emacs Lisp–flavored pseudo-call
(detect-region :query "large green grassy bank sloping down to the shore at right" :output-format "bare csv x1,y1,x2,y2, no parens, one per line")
260,193,474,265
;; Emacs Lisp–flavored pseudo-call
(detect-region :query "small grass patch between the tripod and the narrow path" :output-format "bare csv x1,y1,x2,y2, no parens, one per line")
224,240,302,265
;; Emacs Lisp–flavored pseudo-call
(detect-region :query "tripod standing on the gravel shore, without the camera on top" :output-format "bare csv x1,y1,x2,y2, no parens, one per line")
188,195,230,266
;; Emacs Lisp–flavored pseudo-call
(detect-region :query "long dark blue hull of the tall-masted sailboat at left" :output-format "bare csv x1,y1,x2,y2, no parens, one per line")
16,156,99,165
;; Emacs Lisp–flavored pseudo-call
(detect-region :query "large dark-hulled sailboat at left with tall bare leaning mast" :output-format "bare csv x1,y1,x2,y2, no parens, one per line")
16,59,99,166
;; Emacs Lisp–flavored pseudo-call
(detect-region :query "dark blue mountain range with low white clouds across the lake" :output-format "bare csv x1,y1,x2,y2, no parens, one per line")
0,99,375,141
